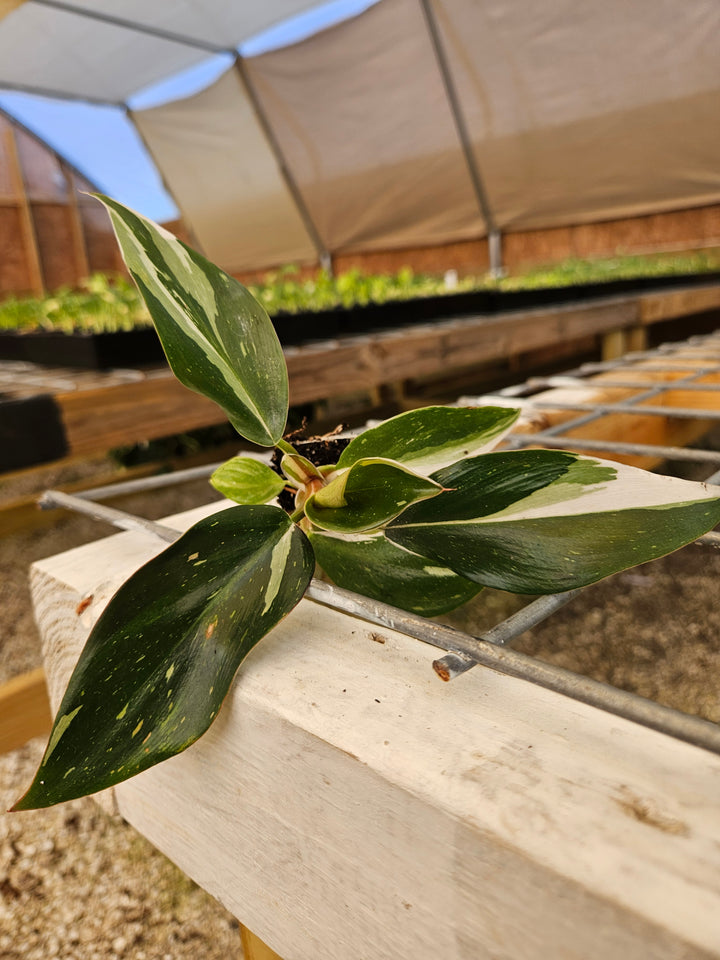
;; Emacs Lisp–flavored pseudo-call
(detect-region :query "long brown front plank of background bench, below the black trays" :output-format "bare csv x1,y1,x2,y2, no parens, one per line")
4,287,720,466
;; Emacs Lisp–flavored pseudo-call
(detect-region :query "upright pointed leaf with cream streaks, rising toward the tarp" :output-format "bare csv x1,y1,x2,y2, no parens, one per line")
99,197,288,446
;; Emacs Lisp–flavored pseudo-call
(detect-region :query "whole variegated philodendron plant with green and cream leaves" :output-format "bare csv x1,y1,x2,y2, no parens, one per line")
14,198,720,810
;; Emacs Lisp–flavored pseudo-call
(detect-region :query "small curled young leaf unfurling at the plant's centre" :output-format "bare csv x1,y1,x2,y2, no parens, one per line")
305,457,442,533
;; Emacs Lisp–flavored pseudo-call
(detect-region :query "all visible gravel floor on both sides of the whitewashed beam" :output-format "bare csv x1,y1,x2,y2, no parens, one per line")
0,461,720,960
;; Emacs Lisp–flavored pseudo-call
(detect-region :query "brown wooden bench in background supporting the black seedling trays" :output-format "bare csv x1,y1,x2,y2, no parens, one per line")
5,285,720,472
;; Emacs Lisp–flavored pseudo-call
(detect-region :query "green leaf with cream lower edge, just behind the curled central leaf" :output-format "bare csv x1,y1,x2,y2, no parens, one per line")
338,407,520,476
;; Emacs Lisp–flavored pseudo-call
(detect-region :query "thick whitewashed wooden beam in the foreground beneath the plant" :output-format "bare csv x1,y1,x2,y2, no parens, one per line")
32,509,720,960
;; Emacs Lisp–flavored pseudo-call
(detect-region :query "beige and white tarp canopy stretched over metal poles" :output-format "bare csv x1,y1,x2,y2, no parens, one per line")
0,0,720,270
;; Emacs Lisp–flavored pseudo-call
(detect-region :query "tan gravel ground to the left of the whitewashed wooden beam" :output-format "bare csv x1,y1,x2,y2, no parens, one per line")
0,461,242,960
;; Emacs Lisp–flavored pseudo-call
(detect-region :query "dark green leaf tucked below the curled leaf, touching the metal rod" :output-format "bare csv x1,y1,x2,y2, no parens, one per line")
309,532,482,617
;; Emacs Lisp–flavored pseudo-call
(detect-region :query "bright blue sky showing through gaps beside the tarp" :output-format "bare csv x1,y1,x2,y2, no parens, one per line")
0,0,377,221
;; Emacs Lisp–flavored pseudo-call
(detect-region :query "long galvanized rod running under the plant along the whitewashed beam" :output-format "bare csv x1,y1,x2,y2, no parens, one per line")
36,490,720,754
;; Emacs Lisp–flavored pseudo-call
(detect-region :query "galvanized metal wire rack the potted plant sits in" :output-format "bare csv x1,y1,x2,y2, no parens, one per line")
40,331,720,754
